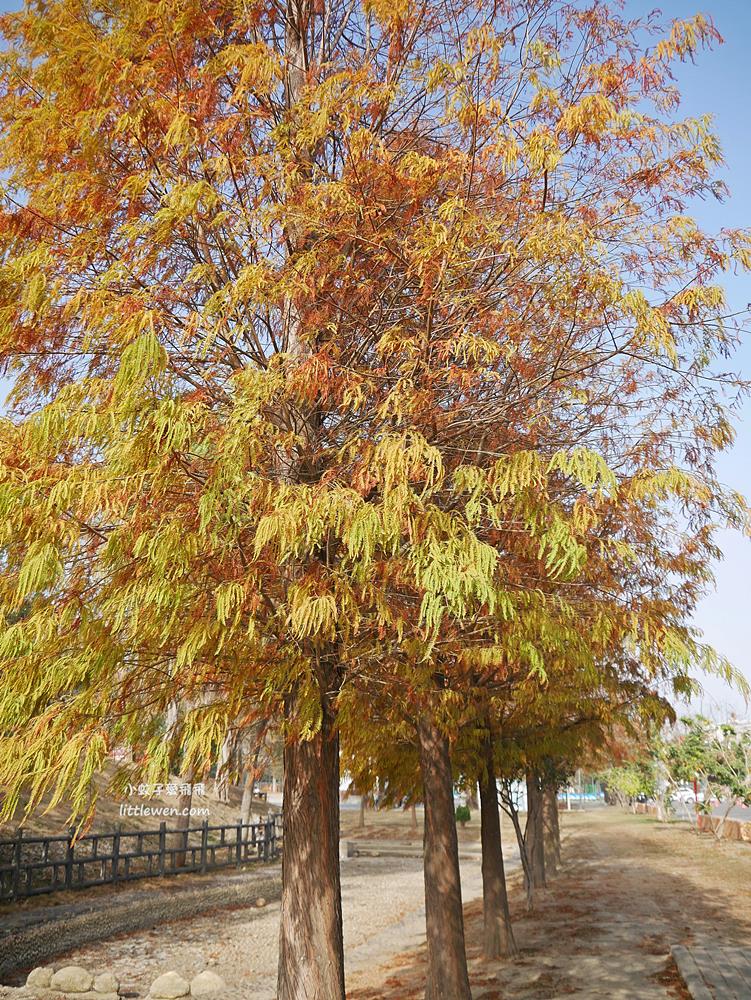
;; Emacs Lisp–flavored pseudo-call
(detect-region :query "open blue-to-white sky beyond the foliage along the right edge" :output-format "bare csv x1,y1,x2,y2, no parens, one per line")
0,0,751,715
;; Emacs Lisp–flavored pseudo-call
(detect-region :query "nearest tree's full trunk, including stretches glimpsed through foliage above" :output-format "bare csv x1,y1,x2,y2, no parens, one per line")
276,0,344,1000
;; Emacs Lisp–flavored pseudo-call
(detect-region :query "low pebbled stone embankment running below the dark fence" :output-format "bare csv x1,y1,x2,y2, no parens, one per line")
0,866,282,981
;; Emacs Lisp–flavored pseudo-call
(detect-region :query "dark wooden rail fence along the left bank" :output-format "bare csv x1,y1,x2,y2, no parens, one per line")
0,814,282,902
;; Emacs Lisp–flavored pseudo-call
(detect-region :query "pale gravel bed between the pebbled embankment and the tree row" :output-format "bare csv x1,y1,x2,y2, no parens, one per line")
19,857,514,1000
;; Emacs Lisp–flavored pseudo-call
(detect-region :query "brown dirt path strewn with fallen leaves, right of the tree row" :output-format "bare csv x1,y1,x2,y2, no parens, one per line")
349,808,751,1000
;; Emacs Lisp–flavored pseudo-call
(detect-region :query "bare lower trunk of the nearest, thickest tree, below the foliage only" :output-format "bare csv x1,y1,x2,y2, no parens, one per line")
276,688,344,1000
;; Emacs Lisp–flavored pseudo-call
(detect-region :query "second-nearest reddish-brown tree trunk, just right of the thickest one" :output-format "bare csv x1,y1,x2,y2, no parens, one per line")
418,718,472,1000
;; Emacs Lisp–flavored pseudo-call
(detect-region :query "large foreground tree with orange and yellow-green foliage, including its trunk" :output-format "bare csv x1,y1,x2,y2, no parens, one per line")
0,0,749,1000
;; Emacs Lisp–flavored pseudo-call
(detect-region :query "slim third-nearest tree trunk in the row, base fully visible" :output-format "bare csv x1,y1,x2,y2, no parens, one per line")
480,732,519,958
